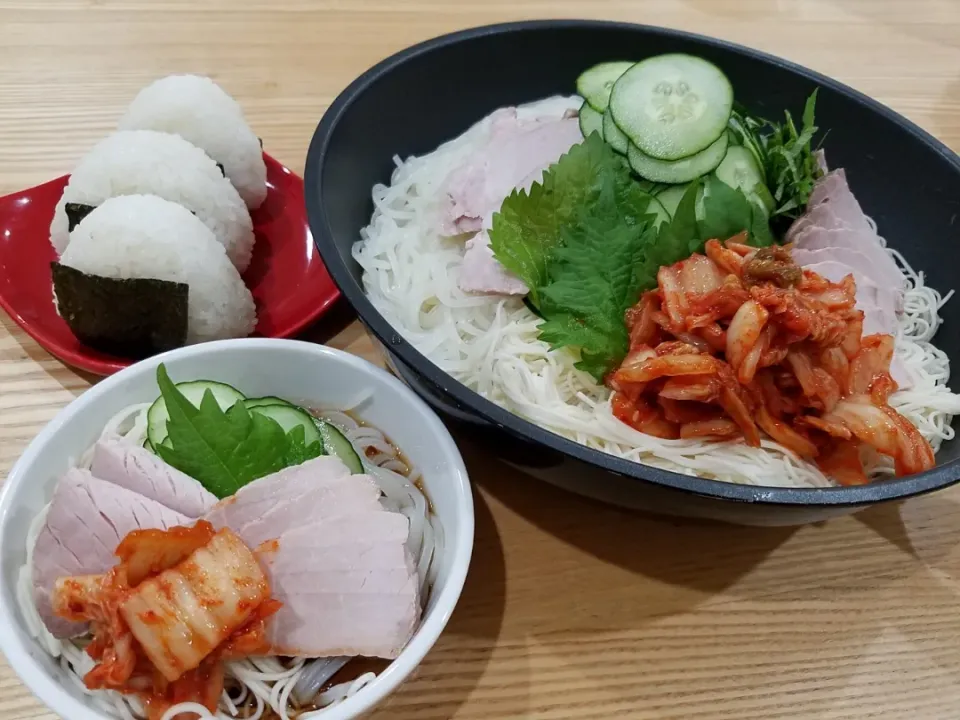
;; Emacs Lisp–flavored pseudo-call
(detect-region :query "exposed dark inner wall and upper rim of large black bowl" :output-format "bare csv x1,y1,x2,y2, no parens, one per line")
306,21,960,484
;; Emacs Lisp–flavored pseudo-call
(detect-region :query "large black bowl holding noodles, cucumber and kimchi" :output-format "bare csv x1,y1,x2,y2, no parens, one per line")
305,16,960,525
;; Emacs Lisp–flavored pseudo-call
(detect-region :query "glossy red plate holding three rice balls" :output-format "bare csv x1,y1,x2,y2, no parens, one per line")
0,153,340,375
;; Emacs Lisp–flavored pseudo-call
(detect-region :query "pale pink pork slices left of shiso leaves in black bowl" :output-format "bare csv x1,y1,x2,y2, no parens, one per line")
444,108,583,295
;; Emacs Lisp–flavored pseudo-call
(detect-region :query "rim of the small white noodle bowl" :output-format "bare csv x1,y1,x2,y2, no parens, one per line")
0,338,475,720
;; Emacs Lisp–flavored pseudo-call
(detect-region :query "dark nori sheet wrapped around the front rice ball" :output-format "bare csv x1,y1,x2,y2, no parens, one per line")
51,262,189,358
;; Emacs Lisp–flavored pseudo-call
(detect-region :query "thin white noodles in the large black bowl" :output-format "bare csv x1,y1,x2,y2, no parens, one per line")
353,98,960,487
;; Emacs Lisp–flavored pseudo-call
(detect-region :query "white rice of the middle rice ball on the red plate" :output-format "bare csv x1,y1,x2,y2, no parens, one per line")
50,130,254,272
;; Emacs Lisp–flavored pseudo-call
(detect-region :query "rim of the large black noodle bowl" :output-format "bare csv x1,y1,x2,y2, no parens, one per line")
304,19,960,507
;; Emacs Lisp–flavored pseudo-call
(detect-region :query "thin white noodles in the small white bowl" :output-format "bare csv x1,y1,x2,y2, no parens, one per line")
16,402,443,720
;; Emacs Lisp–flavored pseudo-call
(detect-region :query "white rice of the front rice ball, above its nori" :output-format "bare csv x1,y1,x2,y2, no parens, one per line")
60,195,257,343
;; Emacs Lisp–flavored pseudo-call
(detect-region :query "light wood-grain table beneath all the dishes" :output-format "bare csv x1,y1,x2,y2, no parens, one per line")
0,0,960,720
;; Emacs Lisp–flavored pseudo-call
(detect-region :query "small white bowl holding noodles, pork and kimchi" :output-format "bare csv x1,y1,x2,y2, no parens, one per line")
0,339,474,720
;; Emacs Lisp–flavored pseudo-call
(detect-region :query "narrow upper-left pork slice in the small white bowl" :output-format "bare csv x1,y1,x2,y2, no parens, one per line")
90,436,217,518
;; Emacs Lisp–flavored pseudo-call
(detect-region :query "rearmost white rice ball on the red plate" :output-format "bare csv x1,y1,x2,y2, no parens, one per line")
118,75,267,210
